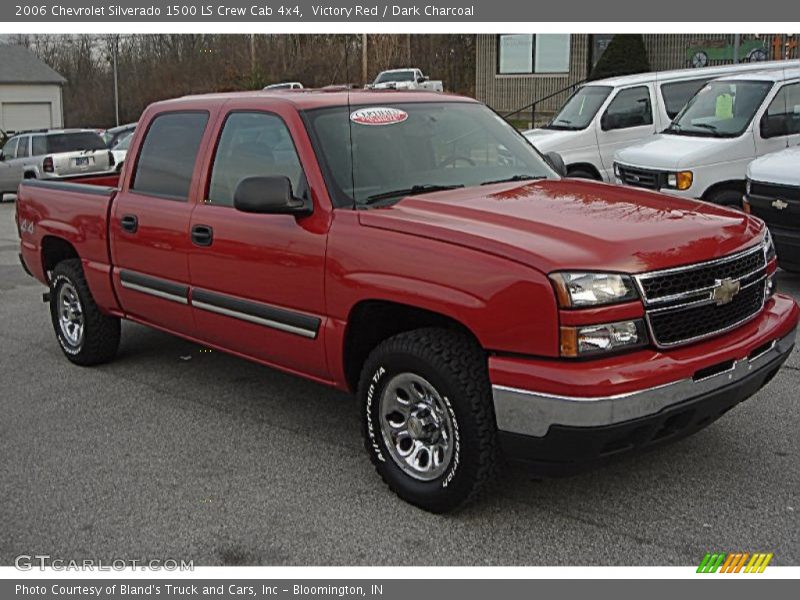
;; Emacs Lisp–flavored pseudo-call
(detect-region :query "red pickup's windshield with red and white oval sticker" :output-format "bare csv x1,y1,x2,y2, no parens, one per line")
304,102,557,206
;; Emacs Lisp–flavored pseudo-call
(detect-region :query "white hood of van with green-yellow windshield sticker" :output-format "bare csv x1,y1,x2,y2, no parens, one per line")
614,133,753,170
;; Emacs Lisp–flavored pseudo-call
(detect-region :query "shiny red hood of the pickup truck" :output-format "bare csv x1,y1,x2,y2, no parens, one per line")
359,179,763,273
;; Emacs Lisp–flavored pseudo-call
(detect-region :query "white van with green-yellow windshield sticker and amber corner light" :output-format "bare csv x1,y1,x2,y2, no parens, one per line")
614,67,800,206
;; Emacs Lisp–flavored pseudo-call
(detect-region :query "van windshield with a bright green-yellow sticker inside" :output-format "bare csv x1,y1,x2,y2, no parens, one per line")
664,80,773,137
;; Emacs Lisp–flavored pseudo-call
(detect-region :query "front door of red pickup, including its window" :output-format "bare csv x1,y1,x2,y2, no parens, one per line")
189,107,327,378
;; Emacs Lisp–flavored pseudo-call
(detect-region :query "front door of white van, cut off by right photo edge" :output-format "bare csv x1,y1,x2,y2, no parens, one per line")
754,82,800,156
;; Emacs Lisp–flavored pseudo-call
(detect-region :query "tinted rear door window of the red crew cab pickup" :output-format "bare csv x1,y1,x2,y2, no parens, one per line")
131,112,208,200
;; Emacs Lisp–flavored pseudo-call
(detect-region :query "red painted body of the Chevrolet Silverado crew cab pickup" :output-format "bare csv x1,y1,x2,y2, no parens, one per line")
17,92,798,396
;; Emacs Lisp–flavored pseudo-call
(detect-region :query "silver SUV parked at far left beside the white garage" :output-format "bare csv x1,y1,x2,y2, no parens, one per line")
0,129,114,193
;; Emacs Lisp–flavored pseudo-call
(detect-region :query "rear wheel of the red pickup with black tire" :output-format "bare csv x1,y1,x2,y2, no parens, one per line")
50,258,120,366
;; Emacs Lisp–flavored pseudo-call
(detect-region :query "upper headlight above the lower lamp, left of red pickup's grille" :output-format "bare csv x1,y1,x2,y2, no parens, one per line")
550,272,639,308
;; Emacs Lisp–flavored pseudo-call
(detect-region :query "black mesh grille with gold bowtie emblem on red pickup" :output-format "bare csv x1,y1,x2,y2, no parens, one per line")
636,245,767,347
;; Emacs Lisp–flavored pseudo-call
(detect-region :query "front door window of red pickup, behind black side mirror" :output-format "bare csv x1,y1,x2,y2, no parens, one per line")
208,112,303,206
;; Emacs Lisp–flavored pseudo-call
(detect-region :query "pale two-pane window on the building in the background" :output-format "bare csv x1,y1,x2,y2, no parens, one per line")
497,33,570,75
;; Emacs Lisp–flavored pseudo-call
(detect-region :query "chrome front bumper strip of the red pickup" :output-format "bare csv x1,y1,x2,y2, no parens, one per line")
492,329,797,437
